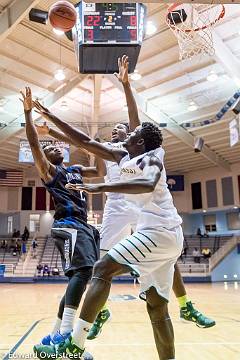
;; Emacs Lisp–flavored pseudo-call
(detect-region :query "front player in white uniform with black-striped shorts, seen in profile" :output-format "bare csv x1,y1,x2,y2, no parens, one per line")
52,122,183,360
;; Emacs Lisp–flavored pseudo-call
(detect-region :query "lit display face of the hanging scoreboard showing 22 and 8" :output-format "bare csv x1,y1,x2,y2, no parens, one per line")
82,3,138,44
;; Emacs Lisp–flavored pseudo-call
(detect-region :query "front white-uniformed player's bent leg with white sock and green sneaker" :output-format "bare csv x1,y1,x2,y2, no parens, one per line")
46,255,129,358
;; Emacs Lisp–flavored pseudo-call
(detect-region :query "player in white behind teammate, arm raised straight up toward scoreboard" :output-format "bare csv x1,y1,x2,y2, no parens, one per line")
88,56,215,340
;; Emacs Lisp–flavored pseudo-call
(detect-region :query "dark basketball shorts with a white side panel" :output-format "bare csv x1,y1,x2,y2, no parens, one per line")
52,223,100,276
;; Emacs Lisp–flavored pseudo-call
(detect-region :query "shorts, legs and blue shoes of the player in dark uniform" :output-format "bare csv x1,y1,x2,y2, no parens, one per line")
34,225,98,354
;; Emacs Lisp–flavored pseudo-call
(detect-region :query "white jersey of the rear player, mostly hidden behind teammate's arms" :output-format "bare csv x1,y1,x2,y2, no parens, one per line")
103,142,124,199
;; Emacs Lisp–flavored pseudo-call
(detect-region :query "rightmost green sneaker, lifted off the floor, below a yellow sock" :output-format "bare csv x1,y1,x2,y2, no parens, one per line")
180,301,216,328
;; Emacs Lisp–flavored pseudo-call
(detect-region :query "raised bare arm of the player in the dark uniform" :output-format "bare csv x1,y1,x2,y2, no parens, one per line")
20,87,55,182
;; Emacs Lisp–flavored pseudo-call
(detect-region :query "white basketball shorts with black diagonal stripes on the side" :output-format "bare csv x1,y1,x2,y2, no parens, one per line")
108,226,183,301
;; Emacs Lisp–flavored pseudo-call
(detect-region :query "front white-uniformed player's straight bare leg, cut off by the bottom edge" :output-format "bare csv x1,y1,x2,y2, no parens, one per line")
146,287,175,360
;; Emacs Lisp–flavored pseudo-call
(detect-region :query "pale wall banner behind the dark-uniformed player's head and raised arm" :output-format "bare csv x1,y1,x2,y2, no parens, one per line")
18,140,70,163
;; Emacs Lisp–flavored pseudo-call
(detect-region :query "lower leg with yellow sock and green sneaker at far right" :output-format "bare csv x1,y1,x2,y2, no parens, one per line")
173,263,216,328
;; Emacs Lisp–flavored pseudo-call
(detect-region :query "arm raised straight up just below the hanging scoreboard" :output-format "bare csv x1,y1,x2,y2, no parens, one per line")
114,55,140,131
